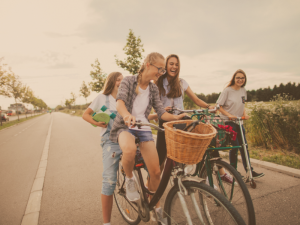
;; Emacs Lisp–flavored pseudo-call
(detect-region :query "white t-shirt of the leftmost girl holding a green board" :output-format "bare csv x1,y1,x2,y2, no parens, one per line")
89,94,117,136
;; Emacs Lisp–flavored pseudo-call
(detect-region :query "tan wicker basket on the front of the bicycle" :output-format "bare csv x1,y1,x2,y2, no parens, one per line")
163,120,217,164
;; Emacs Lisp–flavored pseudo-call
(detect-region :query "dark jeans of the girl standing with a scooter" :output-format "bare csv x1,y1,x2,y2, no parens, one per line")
226,122,253,171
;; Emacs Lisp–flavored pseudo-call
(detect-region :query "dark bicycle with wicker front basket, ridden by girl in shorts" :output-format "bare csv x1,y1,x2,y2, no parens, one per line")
114,121,245,225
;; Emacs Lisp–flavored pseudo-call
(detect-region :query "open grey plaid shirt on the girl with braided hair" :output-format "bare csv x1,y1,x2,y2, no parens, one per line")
109,75,166,142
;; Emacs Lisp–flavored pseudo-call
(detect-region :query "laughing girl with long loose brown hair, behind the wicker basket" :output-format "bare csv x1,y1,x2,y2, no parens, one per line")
156,54,214,165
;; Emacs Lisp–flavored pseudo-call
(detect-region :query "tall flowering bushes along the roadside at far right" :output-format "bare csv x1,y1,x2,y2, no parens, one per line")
246,94,300,152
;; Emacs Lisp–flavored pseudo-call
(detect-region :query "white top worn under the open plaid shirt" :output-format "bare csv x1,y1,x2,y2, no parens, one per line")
130,86,151,131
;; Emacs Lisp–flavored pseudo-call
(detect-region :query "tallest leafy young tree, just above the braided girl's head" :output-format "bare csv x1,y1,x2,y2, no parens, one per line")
115,29,145,75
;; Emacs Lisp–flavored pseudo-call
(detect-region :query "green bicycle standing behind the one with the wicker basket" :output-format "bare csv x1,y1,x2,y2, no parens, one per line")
166,108,256,225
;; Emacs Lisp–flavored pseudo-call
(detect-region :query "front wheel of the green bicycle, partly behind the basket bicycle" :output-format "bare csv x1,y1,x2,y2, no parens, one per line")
200,160,256,225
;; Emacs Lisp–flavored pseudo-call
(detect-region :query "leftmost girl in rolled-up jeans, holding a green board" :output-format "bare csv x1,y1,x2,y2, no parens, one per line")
82,72,123,224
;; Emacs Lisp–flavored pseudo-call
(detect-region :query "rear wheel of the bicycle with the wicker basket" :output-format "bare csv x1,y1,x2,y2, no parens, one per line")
114,163,141,225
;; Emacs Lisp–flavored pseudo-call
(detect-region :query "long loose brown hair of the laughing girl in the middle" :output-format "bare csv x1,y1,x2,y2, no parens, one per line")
156,54,182,98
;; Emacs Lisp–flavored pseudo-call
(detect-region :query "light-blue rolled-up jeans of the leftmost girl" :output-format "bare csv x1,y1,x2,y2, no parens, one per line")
100,133,122,196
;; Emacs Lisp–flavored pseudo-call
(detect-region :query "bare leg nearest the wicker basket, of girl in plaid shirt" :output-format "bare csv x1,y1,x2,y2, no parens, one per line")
140,141,160,207
